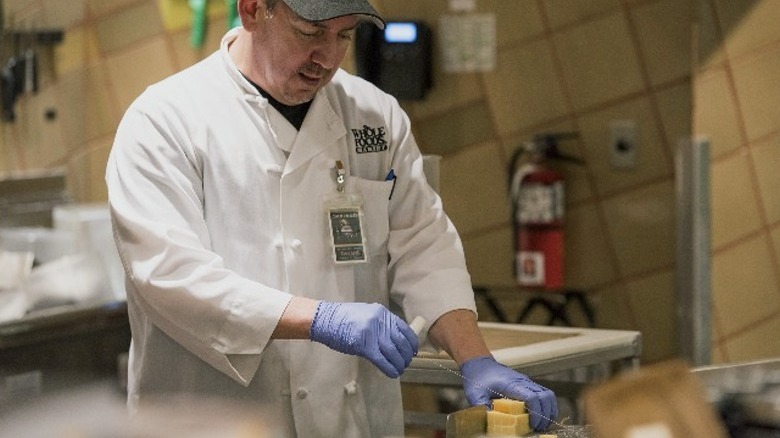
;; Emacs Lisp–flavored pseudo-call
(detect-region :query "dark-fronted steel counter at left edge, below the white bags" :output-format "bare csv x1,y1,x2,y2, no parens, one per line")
0,301,130,410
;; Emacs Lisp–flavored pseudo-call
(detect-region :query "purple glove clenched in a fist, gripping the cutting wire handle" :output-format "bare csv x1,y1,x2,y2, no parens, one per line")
310,301,417,378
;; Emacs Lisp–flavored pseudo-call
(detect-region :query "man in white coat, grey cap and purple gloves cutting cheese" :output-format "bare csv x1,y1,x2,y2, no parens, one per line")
106,0,557,437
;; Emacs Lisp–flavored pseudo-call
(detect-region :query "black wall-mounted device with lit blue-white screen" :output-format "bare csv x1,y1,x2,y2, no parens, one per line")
355,21,433,100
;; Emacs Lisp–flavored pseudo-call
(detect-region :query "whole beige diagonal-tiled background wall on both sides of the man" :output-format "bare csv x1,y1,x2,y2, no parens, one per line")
0,0,780,362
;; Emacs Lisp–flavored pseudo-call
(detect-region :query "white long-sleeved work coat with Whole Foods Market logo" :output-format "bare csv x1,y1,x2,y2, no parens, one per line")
106,30,475,437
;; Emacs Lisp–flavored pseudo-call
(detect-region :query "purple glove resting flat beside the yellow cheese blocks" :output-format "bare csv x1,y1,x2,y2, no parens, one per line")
460,356,558,431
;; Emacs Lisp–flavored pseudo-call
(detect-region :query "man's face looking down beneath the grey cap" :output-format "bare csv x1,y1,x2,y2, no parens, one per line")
252,1,358,105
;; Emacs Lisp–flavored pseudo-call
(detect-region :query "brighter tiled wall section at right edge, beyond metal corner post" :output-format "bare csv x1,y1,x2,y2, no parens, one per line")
693,0,780,362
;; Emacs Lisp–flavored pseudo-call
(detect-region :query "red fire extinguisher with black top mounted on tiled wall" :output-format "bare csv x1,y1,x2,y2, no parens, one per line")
509,133,583,289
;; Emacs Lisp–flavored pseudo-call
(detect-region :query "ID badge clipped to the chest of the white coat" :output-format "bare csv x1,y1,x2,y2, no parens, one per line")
325,193,367,264
